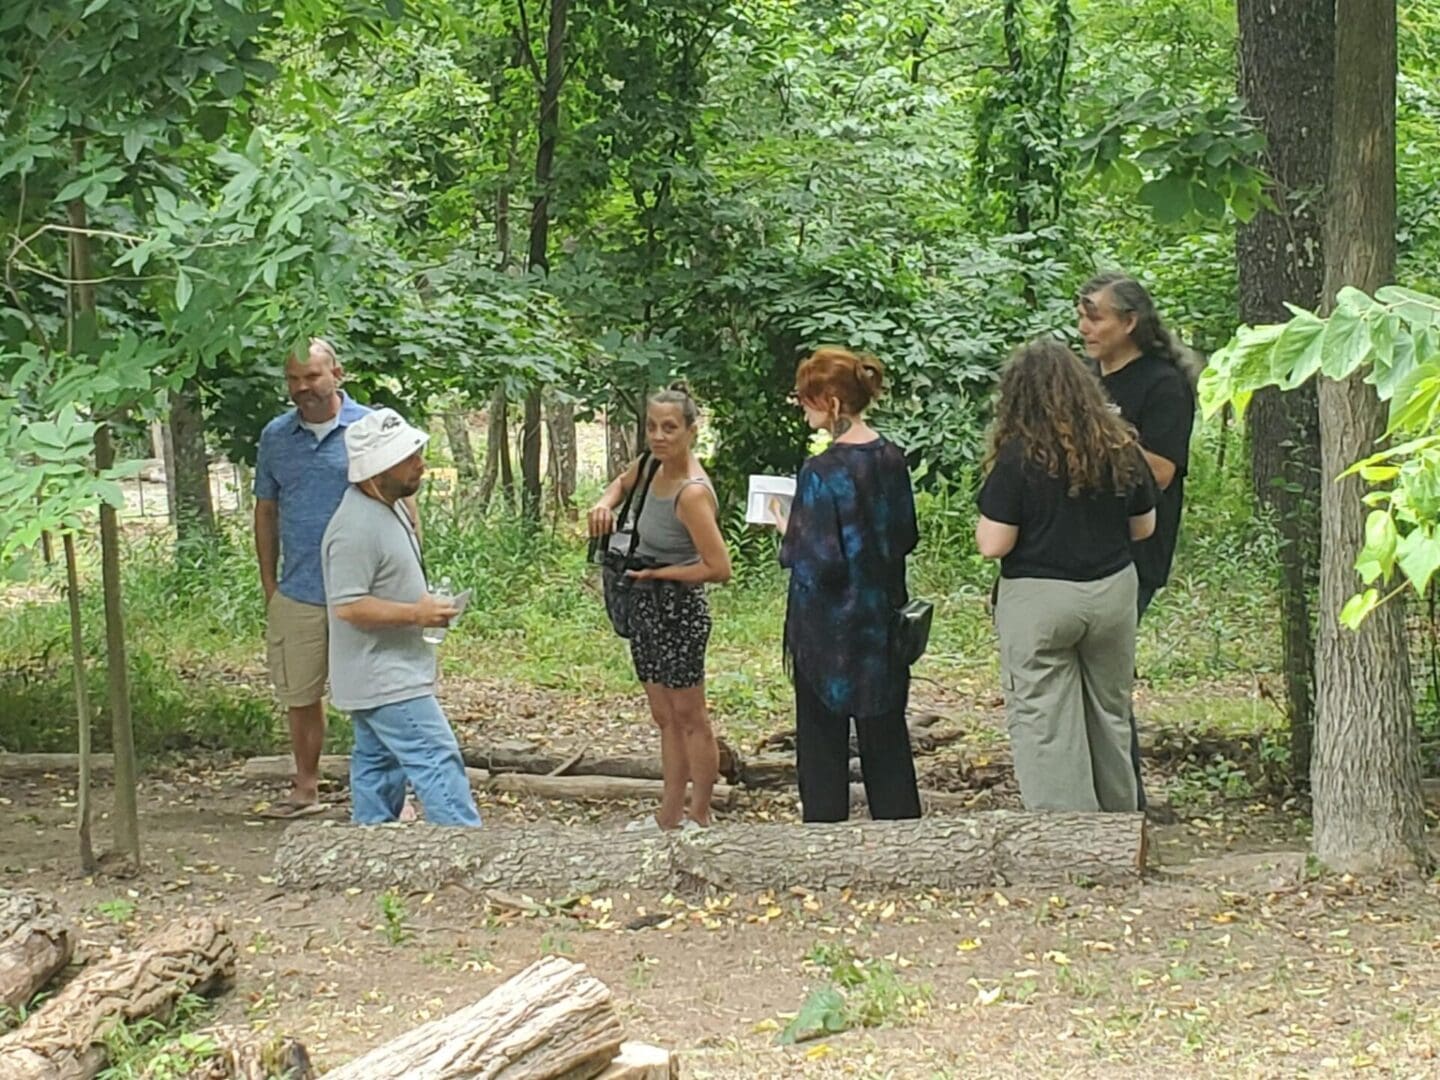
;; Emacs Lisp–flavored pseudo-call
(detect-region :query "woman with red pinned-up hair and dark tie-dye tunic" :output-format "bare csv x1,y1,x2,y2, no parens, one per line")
776,348,920,821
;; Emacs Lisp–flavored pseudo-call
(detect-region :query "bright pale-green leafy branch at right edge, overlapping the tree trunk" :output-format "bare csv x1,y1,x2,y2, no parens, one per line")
1200,285,1440,628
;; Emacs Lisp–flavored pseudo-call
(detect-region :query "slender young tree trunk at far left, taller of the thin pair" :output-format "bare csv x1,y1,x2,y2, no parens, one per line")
66,192,140,870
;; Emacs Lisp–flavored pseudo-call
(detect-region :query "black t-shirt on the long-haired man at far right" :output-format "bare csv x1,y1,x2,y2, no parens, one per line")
1100,356,1195,589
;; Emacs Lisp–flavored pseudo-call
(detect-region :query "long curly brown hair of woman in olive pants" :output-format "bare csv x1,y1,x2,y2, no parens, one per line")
985,338,1146,498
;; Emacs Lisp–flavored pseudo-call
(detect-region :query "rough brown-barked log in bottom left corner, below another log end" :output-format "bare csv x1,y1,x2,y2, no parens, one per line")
0,917,235,1080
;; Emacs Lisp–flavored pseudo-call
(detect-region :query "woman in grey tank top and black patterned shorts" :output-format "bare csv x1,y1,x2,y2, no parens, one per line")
589,383,730,831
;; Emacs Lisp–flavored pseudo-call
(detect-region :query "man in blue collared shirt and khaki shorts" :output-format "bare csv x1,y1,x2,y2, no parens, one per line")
255,337,370,818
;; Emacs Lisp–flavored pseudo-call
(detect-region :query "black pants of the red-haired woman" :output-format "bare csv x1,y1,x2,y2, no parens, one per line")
795,671,920,821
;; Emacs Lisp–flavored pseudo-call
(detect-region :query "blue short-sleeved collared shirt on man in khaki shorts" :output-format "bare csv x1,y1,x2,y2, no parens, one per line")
255,390,370,605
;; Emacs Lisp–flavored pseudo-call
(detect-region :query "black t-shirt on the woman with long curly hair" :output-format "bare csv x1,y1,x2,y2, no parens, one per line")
979,439,1155,582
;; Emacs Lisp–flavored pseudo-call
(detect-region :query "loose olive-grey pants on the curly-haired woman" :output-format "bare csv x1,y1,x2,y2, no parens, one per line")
995,566,1136,811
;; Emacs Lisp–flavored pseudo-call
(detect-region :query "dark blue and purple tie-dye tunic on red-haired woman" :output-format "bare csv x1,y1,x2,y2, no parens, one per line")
780,439,919,717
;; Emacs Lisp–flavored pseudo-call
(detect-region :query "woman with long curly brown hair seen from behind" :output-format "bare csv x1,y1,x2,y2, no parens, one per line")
975,340,1155,811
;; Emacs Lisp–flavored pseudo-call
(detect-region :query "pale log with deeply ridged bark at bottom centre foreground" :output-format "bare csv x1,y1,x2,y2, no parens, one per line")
325,956,624,1080
